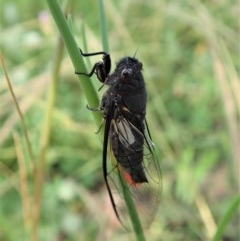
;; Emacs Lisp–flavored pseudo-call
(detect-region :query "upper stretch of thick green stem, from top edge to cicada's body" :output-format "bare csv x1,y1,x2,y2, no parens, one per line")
47,0,102,126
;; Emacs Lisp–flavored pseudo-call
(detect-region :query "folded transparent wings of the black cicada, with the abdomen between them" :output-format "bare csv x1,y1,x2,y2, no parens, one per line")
105,118,161,228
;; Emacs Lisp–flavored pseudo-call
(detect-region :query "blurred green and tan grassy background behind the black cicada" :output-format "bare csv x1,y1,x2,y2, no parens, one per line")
0,0,240,241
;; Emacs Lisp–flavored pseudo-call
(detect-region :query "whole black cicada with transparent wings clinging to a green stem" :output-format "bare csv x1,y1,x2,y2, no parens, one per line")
76,50,161,227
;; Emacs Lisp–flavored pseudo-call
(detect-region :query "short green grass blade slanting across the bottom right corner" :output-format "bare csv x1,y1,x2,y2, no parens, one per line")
212,196,240,241
